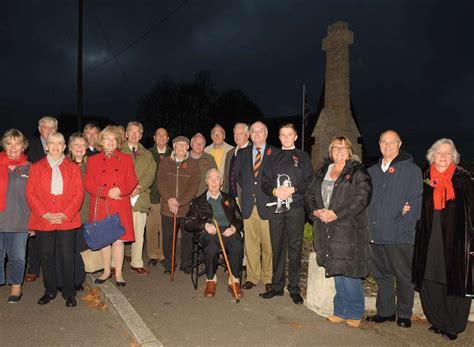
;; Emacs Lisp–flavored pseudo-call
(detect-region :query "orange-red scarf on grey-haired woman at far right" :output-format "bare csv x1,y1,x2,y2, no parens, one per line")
430,163,456,210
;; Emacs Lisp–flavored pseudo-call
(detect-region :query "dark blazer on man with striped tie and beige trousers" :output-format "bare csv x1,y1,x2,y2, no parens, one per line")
236,143,280,219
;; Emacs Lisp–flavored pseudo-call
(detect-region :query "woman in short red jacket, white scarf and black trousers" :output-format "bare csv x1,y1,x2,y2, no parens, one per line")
26,133,84,307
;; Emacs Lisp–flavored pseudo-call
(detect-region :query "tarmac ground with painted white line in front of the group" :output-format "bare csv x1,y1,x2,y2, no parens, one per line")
0,258,474,346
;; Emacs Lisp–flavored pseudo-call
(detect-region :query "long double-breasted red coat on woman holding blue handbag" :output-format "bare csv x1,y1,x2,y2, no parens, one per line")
84,151,138,241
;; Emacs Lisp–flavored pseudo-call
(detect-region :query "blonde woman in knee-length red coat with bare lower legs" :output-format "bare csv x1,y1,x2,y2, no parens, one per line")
84,126,138,286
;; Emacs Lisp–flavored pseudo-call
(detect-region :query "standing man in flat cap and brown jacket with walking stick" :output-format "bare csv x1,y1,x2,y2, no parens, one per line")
156,136,201,273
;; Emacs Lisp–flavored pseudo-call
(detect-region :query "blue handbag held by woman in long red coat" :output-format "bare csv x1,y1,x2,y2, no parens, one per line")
84,186,125,251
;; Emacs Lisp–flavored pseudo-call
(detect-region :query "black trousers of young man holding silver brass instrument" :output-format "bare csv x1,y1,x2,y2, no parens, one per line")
268,208,305,294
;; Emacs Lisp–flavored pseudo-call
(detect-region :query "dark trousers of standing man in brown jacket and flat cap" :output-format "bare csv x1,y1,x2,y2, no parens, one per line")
161,215,193,271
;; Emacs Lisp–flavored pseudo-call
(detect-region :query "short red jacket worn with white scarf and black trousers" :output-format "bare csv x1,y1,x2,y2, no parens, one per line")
26,157,84,231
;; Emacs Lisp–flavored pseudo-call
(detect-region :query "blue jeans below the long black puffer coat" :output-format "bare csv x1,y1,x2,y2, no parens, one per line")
334,276,365,319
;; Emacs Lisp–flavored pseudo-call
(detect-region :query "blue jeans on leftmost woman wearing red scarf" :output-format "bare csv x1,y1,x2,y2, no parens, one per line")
0,231,28,285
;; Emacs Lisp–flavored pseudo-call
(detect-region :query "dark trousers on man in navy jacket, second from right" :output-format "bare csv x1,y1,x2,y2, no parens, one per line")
370,244,415,319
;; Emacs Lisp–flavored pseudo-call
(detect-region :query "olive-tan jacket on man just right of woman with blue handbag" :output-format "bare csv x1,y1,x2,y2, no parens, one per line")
120,142,156,213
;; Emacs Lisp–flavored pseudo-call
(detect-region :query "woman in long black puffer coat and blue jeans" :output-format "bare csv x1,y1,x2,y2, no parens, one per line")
305,136,372,327
